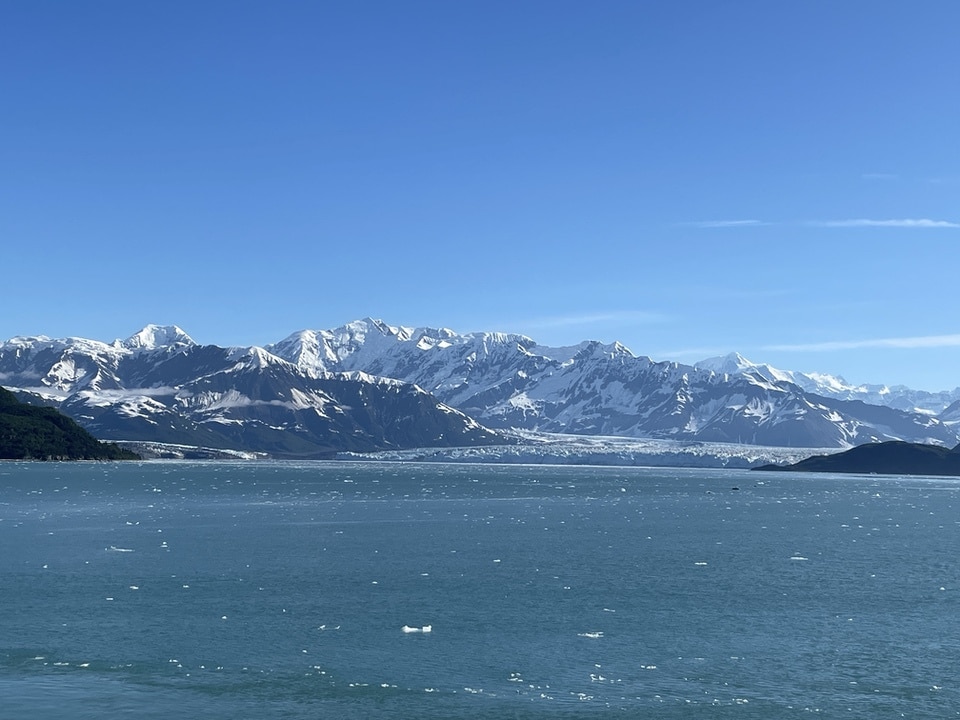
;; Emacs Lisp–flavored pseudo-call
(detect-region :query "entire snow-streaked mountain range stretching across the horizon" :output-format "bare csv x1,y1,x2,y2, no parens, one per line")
0,318,960,457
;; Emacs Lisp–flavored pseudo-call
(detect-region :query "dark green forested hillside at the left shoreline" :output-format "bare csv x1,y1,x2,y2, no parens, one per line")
0,388,138,460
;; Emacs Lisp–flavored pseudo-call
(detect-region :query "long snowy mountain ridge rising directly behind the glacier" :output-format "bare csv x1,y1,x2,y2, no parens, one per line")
268,319,957,447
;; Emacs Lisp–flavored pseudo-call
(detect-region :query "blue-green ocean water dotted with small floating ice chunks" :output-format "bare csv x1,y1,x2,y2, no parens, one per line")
0,462,960,720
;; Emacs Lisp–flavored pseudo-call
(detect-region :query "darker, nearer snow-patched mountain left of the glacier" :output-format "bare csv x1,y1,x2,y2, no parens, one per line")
0,326,497,457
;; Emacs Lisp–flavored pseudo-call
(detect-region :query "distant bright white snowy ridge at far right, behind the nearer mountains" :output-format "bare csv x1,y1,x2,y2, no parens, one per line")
696,353,960,415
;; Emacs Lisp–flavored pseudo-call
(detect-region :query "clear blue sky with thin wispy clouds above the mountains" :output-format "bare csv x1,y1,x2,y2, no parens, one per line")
0,0,960,389
